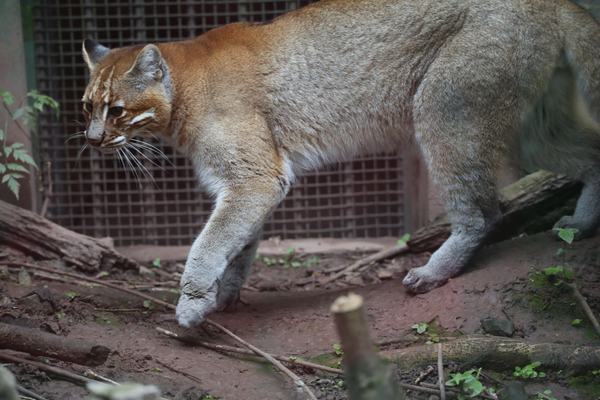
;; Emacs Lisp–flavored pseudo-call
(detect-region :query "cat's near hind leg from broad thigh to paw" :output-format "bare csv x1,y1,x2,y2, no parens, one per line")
404,47,520,293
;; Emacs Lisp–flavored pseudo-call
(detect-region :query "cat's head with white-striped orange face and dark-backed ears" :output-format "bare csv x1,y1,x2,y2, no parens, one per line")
82,39,171,153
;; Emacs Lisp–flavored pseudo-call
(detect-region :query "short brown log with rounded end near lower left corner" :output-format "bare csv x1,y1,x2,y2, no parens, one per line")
0,323,110,366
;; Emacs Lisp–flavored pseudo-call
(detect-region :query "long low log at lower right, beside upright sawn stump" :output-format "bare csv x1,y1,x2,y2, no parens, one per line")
379,335,600,375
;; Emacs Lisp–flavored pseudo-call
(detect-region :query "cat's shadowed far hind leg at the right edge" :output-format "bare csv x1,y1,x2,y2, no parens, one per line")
517,66,600,240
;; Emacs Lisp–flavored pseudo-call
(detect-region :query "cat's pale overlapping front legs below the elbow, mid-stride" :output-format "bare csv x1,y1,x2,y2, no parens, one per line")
176,176,288,327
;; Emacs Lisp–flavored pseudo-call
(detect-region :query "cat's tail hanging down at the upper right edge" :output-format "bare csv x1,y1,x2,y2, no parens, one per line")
558,1,600,124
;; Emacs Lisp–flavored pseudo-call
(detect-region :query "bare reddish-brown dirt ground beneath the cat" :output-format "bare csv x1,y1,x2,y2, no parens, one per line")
0,233,600,400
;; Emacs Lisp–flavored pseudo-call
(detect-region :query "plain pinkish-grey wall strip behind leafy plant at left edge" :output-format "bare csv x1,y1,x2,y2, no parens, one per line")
0,0,37,210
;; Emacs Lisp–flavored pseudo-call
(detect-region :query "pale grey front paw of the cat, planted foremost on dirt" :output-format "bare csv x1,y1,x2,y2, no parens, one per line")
175,279,218,328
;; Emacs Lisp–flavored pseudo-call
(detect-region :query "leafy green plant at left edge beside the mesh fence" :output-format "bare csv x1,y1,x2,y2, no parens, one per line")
0,89,60,199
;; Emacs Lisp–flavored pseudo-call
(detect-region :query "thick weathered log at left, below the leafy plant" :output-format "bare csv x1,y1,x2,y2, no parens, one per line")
0,201,137,272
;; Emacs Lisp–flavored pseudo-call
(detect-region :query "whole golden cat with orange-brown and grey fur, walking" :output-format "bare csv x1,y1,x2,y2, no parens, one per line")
83,0,600,326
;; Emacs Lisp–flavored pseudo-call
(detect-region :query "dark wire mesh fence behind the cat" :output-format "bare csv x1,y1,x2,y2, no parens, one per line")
32,0,422,245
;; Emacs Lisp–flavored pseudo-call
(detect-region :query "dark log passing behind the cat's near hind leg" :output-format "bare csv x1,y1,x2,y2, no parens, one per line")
407,171,582,253
